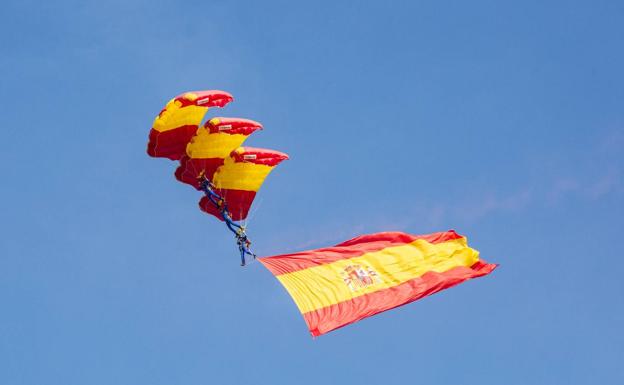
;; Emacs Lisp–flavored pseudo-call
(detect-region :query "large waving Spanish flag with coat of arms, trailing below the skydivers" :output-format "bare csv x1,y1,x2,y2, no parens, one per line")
259,230,497,336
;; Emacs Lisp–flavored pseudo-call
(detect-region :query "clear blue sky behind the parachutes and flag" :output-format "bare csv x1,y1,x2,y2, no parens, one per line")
0,0,624,385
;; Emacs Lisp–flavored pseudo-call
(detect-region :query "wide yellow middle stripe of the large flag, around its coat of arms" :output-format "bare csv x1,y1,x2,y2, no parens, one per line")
277,238,479,313
